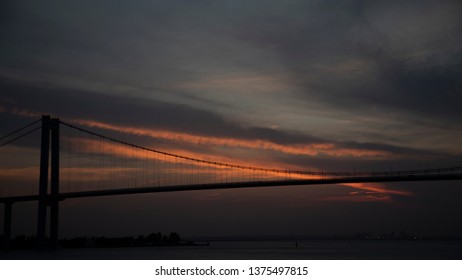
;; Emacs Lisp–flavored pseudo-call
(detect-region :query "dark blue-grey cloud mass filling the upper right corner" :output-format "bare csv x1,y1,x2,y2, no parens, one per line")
233,0,462,121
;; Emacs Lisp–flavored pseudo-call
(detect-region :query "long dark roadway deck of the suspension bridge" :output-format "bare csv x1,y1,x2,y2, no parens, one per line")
0,174,462,203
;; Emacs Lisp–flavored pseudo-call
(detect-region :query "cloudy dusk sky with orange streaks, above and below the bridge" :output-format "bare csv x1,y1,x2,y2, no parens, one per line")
0,0,462,236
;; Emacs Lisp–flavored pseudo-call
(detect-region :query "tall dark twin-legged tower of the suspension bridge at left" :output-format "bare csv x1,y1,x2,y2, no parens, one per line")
37,115,59,249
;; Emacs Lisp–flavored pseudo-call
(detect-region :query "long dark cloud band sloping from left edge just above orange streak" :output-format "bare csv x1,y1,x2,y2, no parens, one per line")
0,76,304,144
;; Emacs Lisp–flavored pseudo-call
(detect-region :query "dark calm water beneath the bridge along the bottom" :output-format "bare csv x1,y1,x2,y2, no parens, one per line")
0,240,462,260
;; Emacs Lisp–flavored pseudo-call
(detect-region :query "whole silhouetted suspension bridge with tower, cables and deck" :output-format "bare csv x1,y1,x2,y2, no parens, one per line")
0,116,462,248
